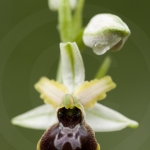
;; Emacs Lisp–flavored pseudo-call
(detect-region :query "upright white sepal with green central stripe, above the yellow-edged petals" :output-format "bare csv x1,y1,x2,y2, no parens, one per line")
60,42,85,94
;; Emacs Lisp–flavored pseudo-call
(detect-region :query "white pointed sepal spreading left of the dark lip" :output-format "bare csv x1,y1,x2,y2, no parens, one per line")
11,104,57,130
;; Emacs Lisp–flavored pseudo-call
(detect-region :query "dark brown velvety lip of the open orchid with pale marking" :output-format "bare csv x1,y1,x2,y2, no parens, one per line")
39,107,99,150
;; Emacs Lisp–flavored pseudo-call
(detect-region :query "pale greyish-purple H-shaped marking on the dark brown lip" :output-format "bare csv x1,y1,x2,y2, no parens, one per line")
54,123,81,150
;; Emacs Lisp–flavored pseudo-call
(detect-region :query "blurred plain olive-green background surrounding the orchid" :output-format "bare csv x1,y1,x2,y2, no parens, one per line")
0,0,150,150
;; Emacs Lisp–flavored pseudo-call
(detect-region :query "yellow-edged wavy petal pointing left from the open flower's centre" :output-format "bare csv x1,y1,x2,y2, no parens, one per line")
35,77,68,107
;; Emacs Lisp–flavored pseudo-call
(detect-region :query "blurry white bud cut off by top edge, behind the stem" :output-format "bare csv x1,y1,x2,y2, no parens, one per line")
48,0,77,11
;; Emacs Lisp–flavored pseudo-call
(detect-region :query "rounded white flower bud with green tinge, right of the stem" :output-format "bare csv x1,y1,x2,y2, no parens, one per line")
83,14,130,55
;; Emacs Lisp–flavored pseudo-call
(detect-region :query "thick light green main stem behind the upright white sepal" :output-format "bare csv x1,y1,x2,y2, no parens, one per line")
56,0,85,83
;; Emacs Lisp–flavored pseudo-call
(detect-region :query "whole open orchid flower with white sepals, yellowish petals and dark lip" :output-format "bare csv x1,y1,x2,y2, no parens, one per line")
12,42,138,150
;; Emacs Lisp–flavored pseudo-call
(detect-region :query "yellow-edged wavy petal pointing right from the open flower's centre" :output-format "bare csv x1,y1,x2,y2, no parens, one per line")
74,76,116,108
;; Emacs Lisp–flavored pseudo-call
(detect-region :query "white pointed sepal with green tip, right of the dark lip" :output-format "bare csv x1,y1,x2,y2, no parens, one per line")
85,103,138,132
